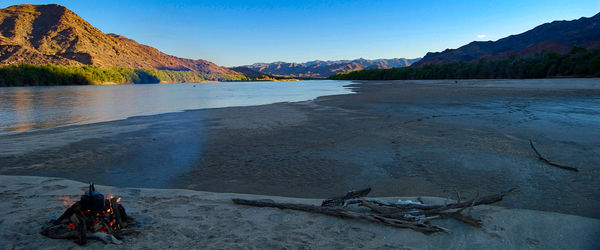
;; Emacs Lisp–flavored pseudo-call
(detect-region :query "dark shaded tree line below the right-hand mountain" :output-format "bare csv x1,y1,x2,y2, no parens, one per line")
329,46,600,80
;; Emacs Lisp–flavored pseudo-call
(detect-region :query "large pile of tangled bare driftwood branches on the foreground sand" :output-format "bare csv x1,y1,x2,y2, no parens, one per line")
233,188,517,233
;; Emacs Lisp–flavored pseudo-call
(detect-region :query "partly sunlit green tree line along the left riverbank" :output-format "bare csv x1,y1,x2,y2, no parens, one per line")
0,64,258,86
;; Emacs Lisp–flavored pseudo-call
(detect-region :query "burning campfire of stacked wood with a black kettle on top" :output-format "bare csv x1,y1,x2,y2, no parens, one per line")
41,183,139,245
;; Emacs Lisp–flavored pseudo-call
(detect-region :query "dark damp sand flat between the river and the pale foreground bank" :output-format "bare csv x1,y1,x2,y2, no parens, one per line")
0,79,600,218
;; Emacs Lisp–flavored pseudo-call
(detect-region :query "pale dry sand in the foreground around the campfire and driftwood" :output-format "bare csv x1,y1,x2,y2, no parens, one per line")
0,176,600,249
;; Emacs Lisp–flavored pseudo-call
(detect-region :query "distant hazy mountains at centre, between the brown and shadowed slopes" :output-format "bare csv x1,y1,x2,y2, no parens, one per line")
242,58,420,78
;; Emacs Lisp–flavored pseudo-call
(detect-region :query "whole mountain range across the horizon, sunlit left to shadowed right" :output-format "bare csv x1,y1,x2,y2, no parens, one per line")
0,4,600,82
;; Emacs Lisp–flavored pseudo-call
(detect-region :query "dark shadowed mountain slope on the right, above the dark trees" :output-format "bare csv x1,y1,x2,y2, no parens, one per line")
413,13,600,66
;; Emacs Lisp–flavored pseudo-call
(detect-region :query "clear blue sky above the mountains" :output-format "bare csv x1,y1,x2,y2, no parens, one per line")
0,0,600,66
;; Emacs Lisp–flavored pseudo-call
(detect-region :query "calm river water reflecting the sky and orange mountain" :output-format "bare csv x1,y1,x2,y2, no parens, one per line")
0,81,351,134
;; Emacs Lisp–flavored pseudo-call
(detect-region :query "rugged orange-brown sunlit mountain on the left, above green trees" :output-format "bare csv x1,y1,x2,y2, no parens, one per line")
0,4,240,75
